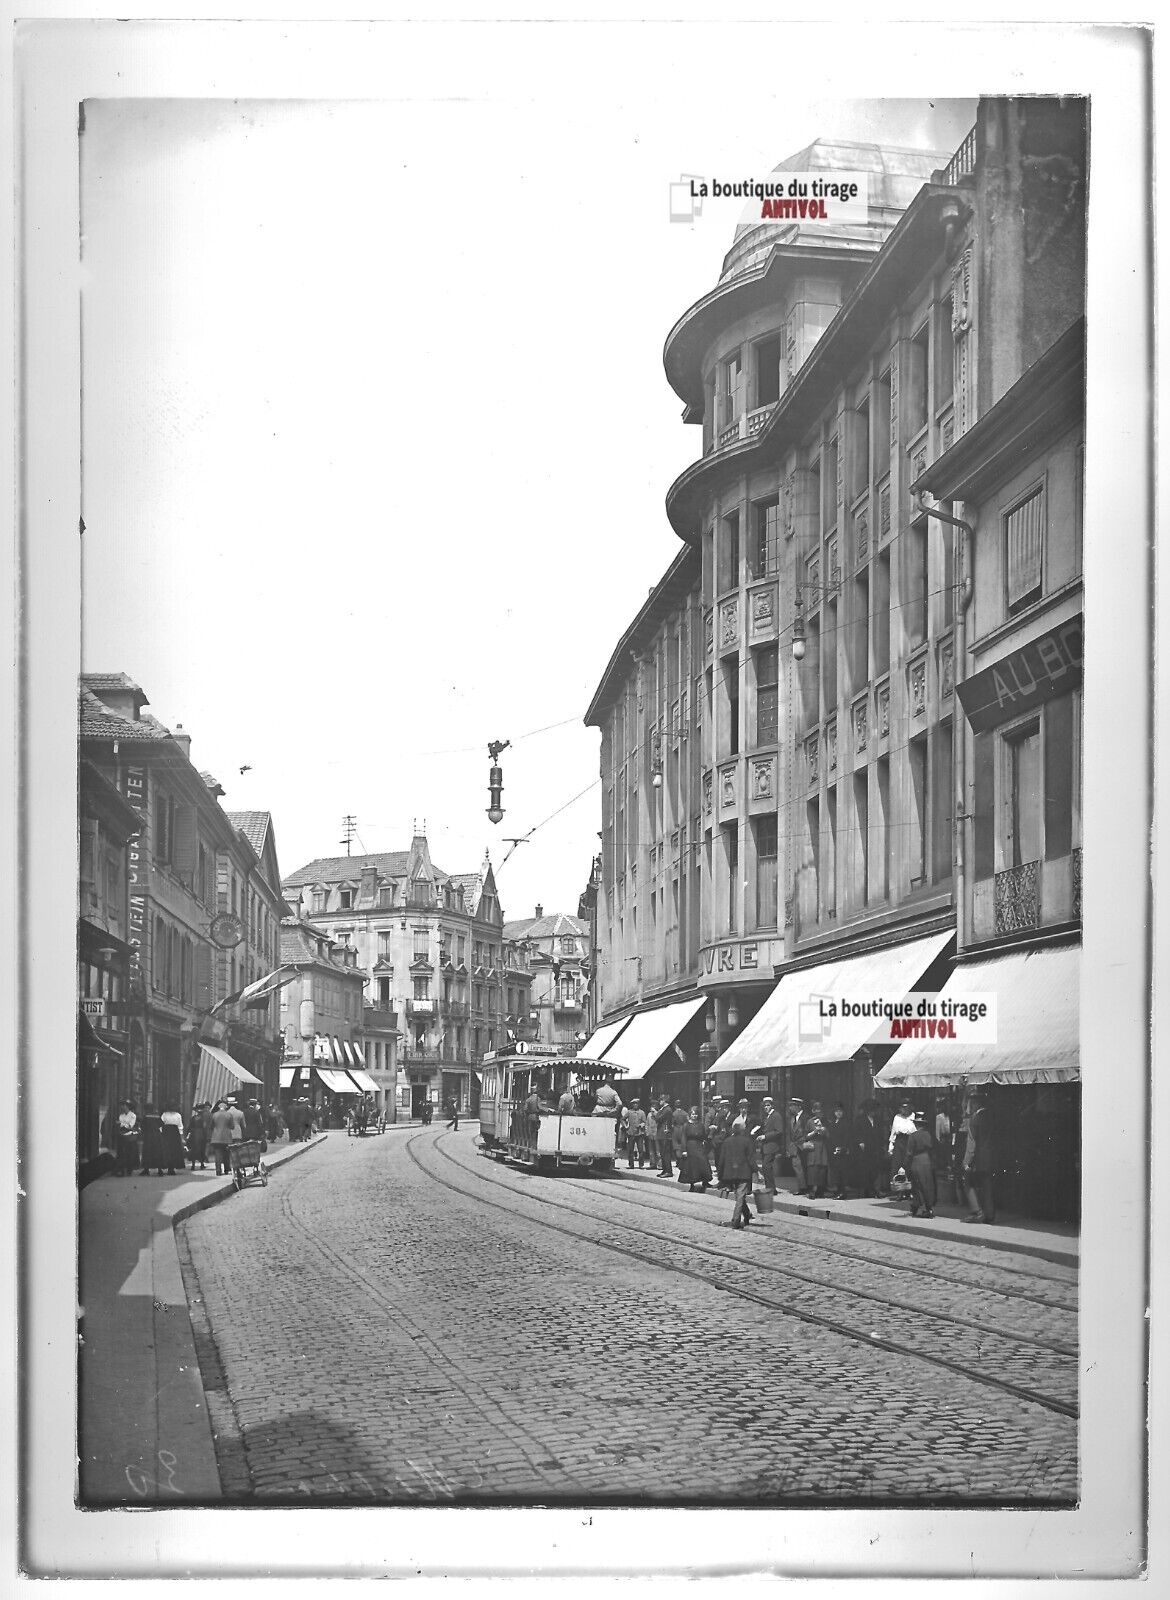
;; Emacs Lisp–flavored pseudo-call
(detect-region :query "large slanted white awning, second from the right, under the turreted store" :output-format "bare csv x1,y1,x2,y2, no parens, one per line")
707,931,954,1072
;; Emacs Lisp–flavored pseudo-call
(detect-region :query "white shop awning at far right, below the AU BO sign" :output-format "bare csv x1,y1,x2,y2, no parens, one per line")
874,944,1080,1088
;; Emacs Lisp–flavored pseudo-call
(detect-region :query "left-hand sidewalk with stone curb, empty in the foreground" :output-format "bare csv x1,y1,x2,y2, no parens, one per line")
78,1133,327,1506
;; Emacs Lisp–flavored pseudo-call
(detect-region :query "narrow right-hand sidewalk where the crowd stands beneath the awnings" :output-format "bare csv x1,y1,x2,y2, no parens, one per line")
616,1157,1080,1267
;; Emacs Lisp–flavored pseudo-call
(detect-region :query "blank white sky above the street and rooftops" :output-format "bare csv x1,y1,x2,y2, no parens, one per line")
80,50,975,918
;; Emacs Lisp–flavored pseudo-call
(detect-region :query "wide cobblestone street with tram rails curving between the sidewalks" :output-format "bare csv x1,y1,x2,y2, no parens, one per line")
179,1123,1077,1504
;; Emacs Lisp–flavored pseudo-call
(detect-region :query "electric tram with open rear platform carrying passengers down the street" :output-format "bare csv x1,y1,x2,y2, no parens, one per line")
480,1045,626,1173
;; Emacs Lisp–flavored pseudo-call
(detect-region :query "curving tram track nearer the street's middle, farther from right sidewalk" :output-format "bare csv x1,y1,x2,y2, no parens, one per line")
405,1134,1079,1418
